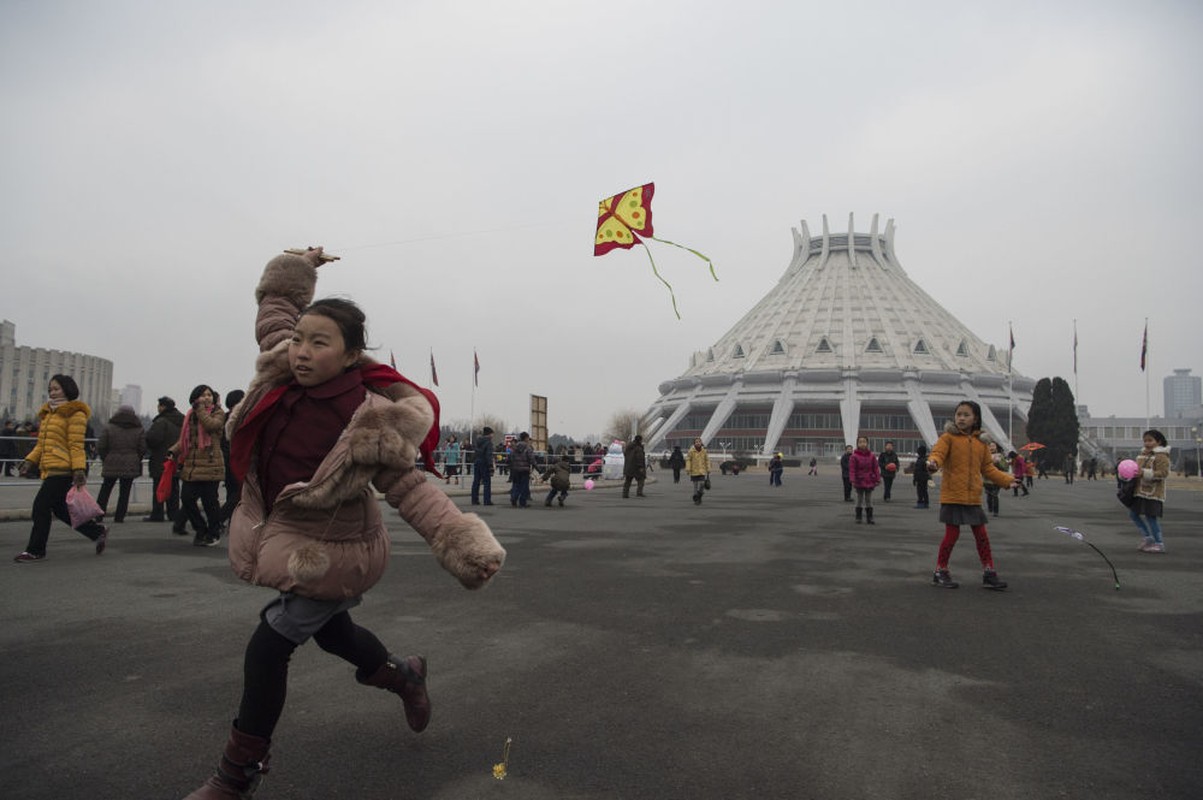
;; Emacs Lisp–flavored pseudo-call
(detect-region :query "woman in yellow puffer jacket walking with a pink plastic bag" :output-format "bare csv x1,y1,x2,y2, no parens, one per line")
13,375,108,564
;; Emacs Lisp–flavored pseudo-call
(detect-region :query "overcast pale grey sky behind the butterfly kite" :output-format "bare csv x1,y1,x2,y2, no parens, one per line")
0,0,1203,437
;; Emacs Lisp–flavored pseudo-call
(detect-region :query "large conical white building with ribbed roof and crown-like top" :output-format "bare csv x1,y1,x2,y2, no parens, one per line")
642,214,1035,457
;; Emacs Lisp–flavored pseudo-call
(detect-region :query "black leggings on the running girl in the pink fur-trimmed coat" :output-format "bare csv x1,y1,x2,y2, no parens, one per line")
238,611,389,739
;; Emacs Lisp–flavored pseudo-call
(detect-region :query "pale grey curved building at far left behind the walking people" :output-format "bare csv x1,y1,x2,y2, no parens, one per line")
0,320,113,422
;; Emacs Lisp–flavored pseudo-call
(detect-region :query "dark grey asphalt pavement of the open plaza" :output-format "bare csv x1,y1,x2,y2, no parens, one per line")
0,469,1203,800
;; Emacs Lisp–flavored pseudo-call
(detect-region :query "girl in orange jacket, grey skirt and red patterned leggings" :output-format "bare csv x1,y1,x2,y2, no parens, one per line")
928,401,1012,589
